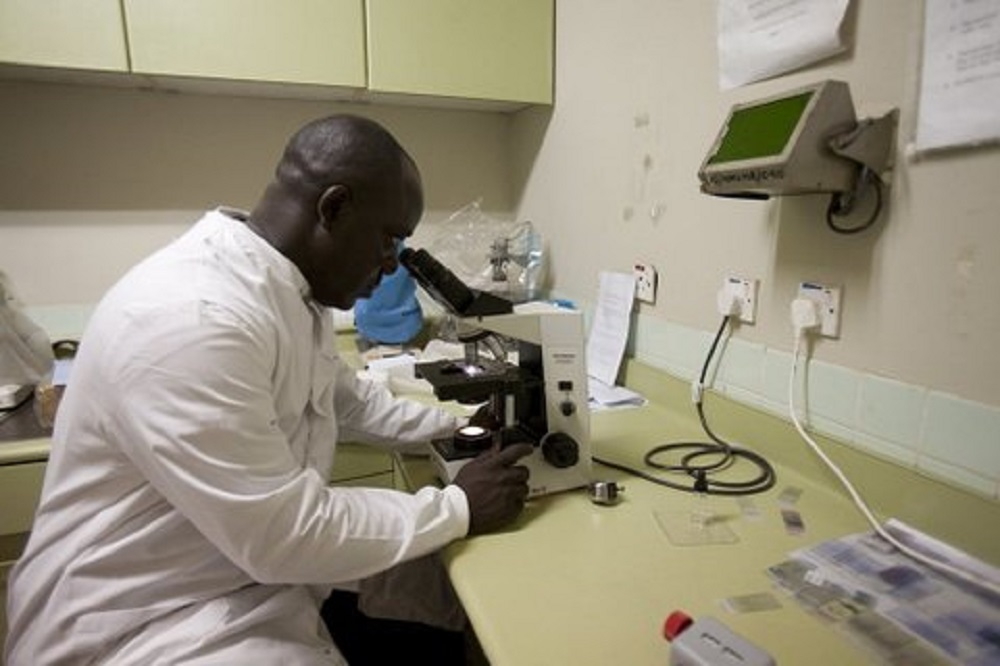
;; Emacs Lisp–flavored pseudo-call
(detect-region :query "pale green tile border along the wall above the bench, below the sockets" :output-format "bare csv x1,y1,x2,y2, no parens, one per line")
628,312,1000,500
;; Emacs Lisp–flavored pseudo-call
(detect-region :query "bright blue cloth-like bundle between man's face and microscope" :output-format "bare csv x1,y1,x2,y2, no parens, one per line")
354,254,424,345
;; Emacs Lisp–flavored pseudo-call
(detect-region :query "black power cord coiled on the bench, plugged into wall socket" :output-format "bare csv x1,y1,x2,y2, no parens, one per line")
594,315,776,495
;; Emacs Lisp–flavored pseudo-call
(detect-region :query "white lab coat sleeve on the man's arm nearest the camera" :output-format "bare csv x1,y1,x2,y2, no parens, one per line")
105,304,469,584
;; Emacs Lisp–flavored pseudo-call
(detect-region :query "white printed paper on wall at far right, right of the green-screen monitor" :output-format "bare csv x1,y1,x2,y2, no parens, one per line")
916,0,1000,150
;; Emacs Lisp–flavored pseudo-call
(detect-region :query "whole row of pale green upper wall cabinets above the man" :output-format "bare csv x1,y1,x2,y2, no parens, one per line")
0,0,555,110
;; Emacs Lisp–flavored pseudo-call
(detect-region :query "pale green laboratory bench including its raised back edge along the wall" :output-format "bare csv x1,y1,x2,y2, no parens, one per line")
405,361,1000,666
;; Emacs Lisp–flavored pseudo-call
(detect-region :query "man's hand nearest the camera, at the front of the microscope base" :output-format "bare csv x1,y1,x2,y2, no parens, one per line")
454,444,534,536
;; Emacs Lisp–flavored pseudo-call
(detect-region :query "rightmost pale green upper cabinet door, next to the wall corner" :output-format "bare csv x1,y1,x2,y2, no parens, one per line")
367,0,555,104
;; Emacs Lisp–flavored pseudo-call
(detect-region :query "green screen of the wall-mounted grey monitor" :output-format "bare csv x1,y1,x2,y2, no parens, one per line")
708,92,813,164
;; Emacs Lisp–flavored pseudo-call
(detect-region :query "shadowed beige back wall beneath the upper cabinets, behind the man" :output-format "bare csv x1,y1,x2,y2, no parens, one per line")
0,81,513,306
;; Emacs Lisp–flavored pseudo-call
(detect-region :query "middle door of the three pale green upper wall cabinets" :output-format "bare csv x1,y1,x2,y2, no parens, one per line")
124,0,365,87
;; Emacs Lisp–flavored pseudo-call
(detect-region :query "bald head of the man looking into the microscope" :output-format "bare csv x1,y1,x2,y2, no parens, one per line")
250,115,423,308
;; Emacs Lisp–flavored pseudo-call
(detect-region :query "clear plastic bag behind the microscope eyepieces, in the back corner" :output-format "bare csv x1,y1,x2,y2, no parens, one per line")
427,201,546,303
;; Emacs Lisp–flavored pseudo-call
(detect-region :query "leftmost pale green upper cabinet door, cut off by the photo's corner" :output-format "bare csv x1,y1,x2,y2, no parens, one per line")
0,0,128,72
